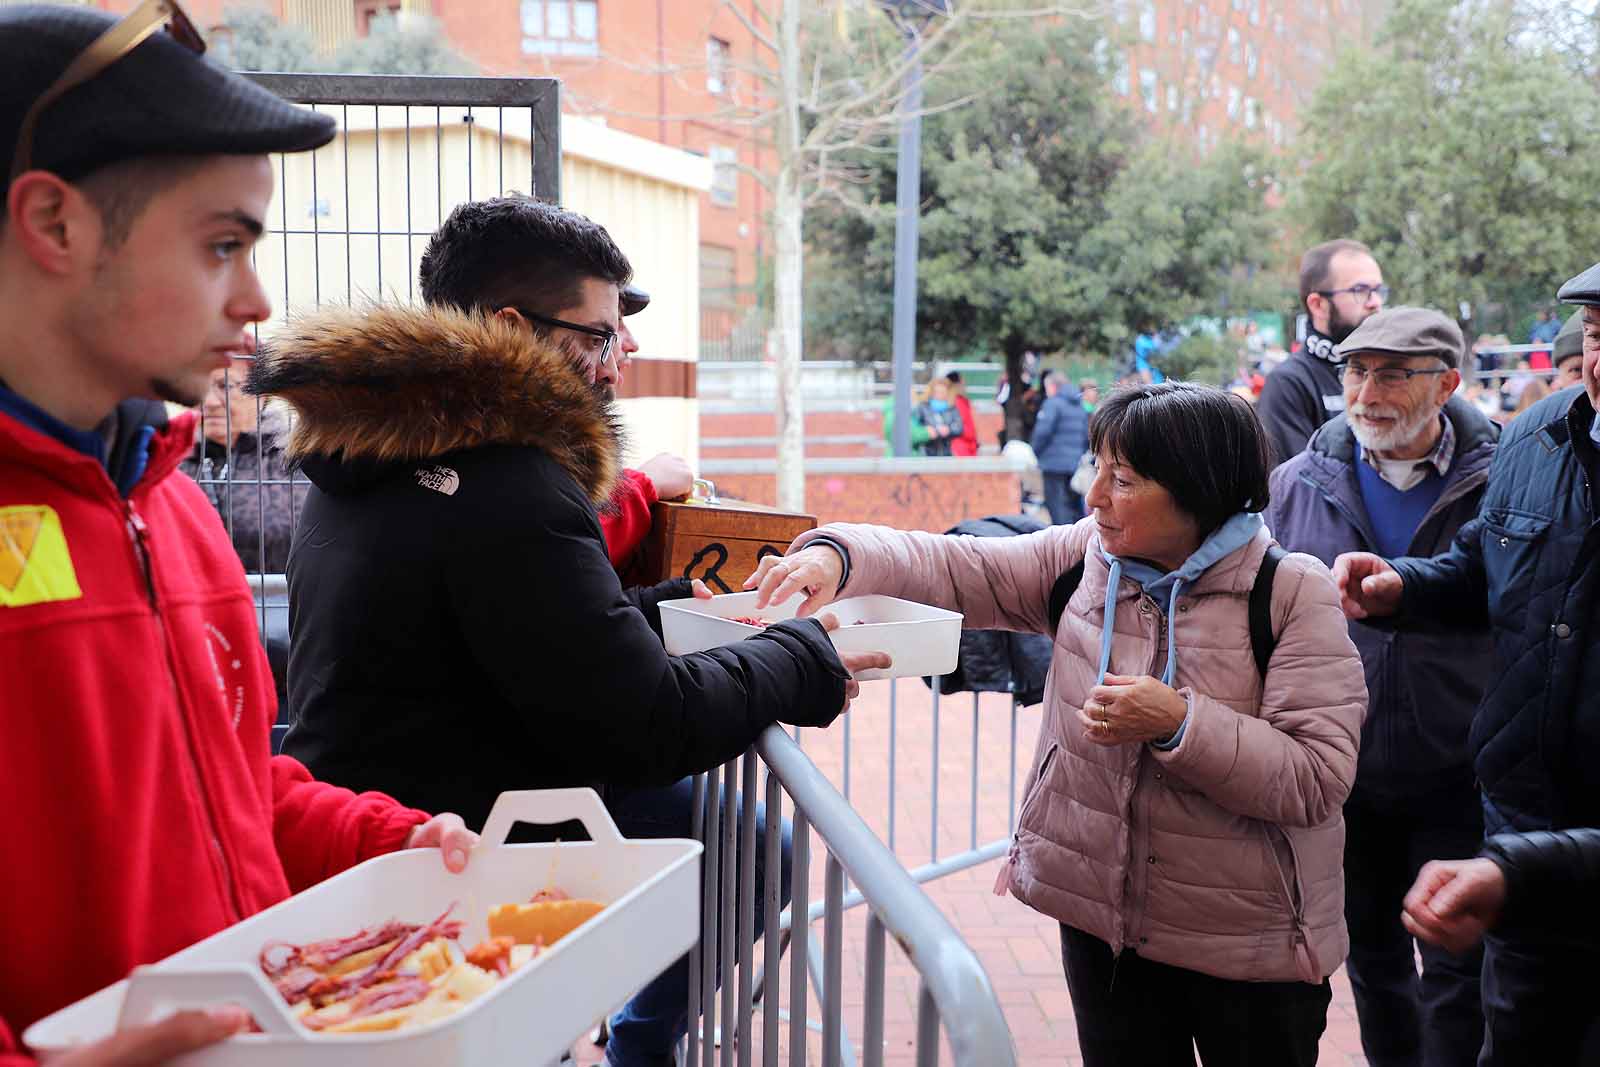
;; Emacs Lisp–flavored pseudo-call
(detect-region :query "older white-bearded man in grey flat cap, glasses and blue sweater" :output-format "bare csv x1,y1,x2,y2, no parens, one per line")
1266,307,1499,1067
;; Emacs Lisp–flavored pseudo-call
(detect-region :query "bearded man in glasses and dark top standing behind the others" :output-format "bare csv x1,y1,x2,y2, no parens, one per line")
1256,240,1389,464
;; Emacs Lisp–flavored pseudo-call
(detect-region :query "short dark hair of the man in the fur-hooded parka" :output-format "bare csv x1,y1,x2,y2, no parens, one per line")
418,195,634,315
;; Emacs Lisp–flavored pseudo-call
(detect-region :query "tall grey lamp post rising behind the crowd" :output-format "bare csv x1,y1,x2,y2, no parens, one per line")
878,0,949,456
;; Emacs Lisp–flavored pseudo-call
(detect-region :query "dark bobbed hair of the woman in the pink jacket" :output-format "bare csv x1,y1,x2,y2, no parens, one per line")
1090,382,1272,536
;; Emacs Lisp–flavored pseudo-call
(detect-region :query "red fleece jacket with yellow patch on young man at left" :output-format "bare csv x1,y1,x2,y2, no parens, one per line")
0,414,427,1067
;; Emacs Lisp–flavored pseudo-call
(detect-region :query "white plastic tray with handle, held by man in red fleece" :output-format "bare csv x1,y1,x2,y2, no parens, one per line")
24,789,701,1067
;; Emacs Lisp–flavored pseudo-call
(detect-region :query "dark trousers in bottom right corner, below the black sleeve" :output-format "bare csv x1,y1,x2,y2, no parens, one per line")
1478,915,1600,1067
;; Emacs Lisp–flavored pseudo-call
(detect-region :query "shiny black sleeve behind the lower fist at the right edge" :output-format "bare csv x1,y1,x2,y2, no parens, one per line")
1482,830,1600,941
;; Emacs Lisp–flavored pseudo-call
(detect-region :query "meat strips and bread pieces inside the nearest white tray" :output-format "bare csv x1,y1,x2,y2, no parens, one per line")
259,888,605,1033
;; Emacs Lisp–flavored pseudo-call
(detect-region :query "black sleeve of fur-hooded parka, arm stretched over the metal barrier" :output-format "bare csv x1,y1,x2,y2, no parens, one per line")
448,450,848,784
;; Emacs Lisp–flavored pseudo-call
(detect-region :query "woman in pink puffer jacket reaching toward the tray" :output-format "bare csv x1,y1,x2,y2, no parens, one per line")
747,384,1366,1067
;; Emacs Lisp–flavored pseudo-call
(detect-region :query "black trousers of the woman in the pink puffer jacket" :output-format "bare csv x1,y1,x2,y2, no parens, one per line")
1061,925,1333,1067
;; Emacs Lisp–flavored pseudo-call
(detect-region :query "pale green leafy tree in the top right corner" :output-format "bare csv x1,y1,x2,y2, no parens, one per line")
1291,0,1600,335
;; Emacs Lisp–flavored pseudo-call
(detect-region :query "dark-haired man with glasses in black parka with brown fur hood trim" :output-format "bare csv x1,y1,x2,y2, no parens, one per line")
260,197,888,1067
